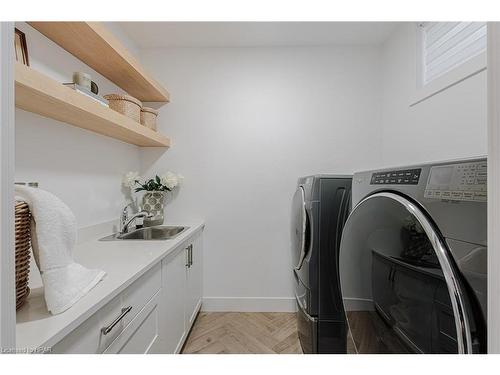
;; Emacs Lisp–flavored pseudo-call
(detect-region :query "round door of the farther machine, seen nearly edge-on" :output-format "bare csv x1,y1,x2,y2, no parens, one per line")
291,186,308,271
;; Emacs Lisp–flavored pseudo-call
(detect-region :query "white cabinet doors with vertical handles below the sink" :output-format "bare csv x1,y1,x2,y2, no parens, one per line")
161,233,203,353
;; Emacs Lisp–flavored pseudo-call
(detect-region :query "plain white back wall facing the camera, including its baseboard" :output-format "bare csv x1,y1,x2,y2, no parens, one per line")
142,47,381,310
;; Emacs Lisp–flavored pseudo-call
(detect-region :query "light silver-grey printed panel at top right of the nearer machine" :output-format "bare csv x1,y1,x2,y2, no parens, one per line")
424,161,487,202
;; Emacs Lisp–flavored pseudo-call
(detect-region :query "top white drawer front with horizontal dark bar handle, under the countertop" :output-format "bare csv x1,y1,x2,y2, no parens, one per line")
52,263,161,354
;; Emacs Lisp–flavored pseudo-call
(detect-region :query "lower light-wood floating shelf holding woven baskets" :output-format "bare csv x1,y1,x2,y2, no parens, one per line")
15,62,170,147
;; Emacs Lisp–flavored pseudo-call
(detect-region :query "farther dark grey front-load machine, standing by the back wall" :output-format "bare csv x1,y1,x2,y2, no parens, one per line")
291,175,352,353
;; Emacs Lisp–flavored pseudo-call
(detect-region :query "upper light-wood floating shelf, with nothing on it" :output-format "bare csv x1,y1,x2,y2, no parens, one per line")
28,22,169,102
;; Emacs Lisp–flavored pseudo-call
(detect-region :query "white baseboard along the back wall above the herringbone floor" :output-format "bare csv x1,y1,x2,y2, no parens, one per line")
201,297,297,312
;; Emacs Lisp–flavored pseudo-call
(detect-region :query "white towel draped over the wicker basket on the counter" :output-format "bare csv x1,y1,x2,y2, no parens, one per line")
16,185,106,314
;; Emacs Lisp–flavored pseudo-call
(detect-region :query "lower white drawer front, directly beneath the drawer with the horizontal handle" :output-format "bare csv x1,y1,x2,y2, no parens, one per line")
104,292,160,354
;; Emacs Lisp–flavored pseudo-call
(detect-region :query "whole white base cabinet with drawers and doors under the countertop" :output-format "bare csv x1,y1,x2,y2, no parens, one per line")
47,231,203,354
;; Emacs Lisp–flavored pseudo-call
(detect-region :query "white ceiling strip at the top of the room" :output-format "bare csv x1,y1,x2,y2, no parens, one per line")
118,22,396,48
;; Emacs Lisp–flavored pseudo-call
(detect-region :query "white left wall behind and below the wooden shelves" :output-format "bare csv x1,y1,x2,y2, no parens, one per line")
15,23,140,227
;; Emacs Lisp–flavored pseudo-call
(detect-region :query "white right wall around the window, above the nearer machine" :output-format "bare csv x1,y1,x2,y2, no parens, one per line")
382,23,487,166
